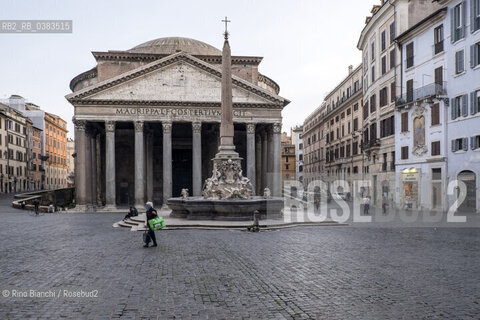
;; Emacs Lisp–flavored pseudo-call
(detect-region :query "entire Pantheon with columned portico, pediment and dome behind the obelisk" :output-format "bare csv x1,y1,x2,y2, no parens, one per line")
66,37,289,210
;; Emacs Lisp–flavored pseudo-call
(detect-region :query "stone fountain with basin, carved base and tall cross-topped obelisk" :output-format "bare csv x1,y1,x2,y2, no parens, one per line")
167,18,283,220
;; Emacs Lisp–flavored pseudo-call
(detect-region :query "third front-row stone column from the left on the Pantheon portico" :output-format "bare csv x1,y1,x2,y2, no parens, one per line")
134,121,145,209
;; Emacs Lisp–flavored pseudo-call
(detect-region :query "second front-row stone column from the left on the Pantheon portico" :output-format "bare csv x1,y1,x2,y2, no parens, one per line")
105,121,117,210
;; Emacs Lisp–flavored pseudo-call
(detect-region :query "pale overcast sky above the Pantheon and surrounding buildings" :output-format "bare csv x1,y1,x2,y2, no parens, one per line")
0,0,374,137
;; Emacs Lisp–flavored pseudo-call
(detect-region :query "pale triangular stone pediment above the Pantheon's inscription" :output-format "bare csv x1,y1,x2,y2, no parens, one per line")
67,52,285,105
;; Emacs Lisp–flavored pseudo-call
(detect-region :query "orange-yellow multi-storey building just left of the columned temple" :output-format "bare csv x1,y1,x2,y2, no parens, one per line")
45,112,68,189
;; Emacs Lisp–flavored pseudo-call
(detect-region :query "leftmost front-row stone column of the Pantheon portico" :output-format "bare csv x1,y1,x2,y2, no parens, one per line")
73,120,87,211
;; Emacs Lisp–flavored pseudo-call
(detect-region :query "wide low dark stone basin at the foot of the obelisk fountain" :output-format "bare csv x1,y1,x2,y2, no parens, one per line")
167,196,283,221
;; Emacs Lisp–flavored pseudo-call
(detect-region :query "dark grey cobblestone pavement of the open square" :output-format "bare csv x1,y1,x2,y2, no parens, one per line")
0,194,480,319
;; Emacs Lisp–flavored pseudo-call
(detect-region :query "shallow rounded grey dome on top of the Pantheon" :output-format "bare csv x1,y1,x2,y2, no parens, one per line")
127,37,222,56
